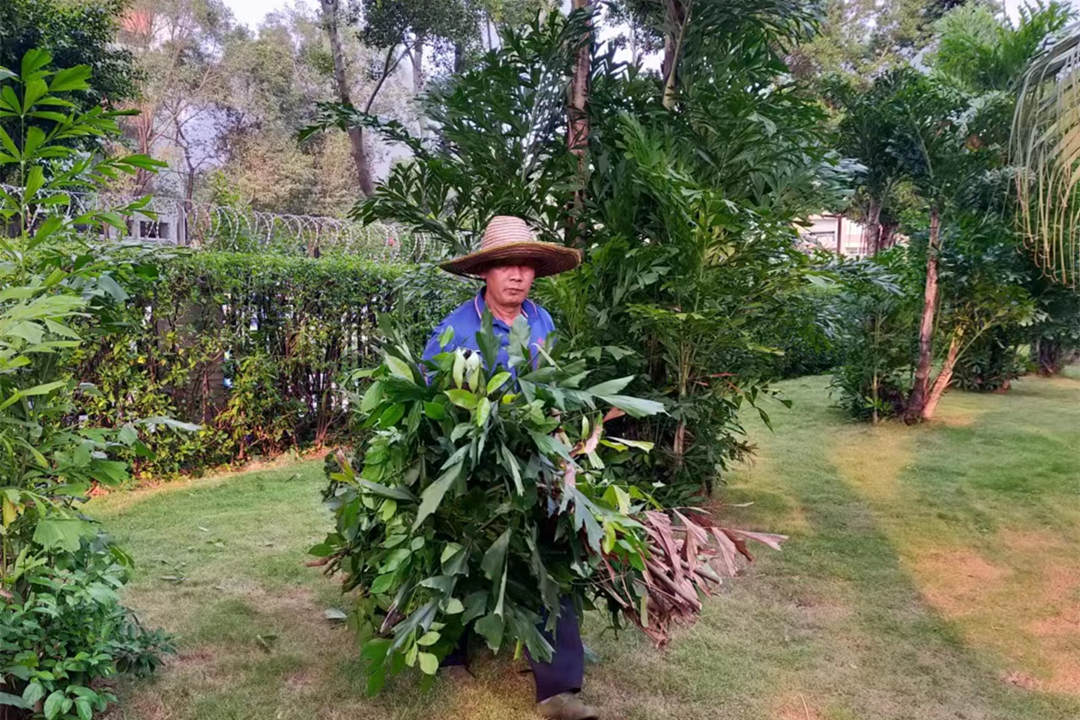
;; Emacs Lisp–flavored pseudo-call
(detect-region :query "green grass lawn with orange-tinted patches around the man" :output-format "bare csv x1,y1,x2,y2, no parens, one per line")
90,369,1080,720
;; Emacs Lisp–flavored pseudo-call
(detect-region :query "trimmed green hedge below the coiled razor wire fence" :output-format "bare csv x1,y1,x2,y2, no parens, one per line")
77,252,471,475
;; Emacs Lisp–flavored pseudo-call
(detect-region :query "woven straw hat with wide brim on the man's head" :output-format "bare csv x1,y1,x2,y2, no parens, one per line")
438,215,581,277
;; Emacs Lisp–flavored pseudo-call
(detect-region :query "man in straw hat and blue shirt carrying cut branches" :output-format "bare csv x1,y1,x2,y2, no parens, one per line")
423,216,598,720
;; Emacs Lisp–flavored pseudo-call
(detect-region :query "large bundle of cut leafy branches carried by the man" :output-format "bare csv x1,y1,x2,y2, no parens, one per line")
311,314,781,691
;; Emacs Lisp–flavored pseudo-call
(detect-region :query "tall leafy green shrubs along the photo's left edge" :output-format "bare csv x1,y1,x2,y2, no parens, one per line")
0,51,171,720
